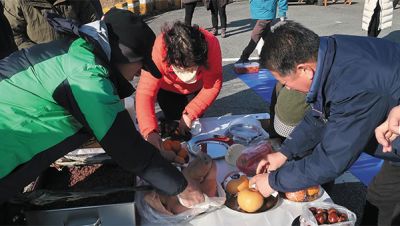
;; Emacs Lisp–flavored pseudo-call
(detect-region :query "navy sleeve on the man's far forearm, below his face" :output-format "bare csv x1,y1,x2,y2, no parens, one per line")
281,109,325,161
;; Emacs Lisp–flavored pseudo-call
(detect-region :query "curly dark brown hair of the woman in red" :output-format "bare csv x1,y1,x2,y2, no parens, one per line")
162,21,208,68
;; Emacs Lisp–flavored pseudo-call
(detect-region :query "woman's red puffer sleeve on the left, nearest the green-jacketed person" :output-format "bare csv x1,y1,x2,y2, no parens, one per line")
136,70,160,137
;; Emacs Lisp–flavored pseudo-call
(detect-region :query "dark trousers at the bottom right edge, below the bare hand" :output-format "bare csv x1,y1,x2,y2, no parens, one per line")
367,161,400,226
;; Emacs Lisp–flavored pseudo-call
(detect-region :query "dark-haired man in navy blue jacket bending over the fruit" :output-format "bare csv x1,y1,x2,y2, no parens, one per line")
250,21,400,225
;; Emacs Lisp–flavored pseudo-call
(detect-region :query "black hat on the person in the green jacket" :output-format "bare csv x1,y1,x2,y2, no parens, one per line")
103,8,161,78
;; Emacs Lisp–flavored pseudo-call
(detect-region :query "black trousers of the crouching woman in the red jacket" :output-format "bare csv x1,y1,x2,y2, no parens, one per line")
157,89,198,120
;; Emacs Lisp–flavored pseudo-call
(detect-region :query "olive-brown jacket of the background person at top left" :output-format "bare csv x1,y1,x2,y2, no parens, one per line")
4,0,97,49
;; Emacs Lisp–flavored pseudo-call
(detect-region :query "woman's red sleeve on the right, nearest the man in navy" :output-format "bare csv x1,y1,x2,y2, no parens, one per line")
184,36,222,120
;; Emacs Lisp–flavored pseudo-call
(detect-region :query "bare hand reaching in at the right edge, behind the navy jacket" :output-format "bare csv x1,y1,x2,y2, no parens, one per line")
375,106,400,152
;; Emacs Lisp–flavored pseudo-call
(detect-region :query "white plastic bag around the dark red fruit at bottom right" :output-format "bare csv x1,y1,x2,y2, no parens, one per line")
300,202,357,226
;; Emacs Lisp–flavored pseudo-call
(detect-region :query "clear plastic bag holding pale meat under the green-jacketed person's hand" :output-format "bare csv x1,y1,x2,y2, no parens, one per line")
135,183,226,225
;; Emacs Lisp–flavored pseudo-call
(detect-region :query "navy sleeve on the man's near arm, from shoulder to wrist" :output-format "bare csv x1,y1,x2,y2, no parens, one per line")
269,93,390,192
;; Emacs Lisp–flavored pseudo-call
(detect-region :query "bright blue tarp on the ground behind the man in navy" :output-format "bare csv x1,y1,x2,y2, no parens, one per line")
238,69,383,185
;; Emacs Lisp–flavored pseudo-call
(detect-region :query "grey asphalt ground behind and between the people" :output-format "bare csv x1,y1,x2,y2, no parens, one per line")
138,0,400,225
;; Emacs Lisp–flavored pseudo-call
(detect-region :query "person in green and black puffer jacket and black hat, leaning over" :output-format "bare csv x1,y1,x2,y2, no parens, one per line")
0,9,204,206
